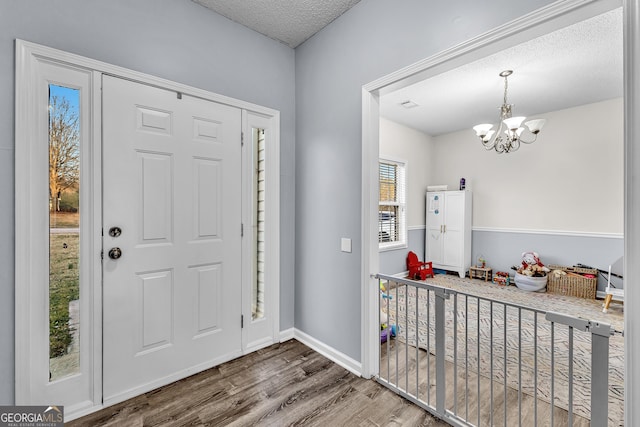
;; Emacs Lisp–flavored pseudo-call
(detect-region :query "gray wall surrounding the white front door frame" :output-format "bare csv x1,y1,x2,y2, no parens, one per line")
0,0,295,405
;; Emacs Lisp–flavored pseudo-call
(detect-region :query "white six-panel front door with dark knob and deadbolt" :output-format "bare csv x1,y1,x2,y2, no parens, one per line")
103,76,241,404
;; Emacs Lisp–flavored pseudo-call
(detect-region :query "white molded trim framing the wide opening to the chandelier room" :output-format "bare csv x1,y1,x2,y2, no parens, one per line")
361,0,640,382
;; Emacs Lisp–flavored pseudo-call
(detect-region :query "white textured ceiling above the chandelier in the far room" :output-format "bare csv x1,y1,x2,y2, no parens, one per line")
380,8,623,136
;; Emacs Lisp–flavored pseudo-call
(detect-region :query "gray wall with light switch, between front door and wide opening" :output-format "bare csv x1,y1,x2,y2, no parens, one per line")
295,0,551,360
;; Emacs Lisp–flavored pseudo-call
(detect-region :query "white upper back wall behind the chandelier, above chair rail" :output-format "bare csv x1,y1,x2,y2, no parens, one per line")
432,98,624,234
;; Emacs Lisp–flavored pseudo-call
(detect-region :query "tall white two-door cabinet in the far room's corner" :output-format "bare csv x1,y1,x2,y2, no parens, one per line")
425,190,472,277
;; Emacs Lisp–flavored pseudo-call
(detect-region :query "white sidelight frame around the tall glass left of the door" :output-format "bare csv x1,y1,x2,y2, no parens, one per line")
15,42,102,413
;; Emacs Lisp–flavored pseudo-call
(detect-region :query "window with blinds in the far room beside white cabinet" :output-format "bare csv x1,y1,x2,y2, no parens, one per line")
378,159,406,248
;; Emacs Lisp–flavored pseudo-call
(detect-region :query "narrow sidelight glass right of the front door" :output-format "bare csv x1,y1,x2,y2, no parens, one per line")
251,128,265,320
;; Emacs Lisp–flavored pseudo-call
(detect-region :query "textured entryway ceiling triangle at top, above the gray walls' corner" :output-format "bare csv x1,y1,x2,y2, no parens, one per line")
193,0,360,48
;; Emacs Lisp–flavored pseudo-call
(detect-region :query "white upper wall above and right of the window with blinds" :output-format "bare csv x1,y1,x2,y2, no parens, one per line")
380,117,433,227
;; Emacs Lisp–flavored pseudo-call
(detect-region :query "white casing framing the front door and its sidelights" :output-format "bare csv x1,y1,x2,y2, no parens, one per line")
14,39,280,421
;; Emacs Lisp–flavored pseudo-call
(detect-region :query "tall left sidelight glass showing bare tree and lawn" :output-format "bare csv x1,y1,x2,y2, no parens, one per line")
49,85,80,381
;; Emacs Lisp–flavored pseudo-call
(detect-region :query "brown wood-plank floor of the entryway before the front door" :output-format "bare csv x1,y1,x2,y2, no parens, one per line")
66,340,447,427
